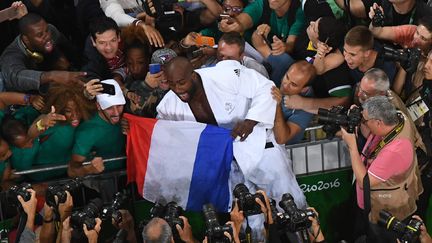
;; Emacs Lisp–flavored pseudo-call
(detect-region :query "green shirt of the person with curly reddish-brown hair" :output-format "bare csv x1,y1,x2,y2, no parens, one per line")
29,124,75,181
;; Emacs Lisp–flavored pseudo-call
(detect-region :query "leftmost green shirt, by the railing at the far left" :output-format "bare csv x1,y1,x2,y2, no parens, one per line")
10,139,40,174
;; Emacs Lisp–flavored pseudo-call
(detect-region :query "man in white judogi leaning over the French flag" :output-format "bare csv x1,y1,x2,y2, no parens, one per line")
157,57,306,222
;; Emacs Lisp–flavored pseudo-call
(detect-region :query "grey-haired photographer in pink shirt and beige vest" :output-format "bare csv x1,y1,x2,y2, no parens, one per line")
341,96,422,242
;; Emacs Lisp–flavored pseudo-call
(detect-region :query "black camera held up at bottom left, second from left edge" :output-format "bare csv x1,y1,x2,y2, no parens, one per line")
45,178,82,207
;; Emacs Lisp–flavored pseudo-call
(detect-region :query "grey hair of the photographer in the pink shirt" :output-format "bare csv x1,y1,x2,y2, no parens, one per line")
363,96,399,126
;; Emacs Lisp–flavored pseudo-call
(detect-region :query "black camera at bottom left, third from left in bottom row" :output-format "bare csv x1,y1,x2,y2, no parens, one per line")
70,198,102,230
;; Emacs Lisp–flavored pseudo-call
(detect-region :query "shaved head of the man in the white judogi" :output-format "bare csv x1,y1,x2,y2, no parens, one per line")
164,57,202,102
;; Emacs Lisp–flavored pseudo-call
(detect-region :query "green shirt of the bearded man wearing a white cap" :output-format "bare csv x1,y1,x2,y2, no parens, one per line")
72,113,126,171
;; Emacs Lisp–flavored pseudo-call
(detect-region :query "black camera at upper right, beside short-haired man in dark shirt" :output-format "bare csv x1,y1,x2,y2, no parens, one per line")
383,46,421,74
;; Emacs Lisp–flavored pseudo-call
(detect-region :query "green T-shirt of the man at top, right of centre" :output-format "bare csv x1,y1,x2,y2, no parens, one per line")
270,7,305,40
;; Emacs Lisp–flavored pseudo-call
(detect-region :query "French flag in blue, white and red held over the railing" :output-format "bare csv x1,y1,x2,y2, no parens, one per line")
124,114,233,212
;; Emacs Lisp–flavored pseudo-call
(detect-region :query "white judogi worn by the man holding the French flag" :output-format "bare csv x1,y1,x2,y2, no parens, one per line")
157,60,306,207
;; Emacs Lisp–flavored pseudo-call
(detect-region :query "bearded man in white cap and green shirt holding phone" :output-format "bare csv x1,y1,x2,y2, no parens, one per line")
68,79,126,178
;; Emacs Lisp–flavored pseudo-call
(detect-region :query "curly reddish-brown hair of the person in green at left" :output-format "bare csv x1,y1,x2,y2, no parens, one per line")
42,84,96,120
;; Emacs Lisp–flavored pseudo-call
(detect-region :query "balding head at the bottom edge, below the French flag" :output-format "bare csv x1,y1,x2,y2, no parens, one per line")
142,218,173,243
